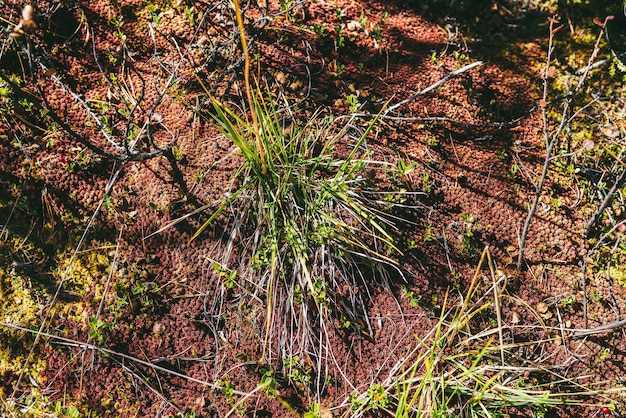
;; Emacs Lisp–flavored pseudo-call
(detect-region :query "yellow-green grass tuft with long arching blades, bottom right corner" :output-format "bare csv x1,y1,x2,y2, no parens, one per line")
342,248,624,418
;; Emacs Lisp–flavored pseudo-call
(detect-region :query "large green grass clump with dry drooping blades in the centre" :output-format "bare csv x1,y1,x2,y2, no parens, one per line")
194,88,408,362
